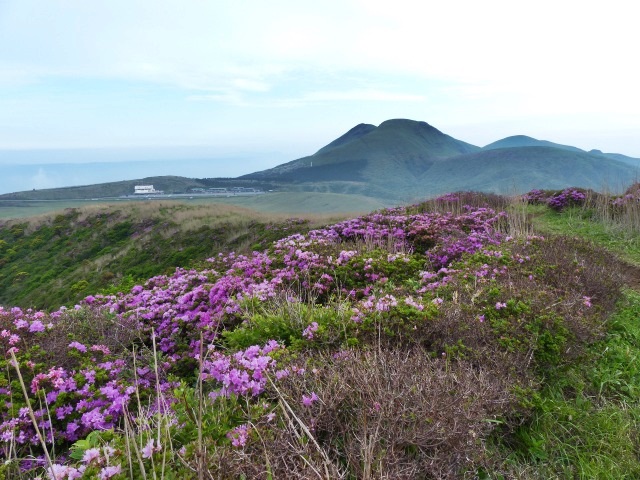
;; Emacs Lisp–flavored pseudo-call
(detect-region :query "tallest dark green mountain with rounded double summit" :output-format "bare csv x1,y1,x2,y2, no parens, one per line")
239,119,480,199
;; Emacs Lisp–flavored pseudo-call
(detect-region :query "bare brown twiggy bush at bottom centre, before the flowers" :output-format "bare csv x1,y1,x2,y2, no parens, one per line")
215,348,514,479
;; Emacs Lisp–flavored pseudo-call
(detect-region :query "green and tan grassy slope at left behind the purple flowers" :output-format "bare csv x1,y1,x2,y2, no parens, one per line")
0,201,350,308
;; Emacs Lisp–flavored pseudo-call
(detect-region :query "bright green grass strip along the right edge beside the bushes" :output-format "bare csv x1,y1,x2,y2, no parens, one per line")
492,193,640,480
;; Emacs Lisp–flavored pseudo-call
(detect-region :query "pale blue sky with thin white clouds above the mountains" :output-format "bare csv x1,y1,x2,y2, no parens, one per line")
0,0,640,189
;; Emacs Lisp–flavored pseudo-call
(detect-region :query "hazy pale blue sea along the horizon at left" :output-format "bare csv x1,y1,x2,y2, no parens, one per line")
0,150,282,194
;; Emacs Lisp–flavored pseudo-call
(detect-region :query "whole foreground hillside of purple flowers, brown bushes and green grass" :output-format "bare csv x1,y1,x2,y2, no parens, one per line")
0,183,640,480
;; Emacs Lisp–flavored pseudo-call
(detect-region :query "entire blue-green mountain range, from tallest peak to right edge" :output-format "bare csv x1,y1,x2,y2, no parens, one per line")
240,119,640,201
